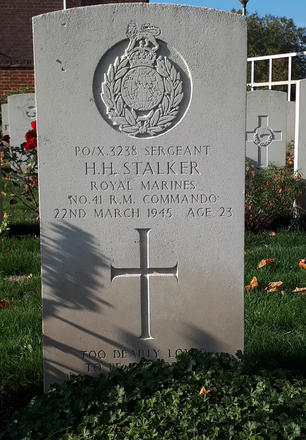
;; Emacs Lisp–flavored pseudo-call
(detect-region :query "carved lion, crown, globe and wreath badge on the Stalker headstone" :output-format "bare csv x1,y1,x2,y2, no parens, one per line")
101,22,184,137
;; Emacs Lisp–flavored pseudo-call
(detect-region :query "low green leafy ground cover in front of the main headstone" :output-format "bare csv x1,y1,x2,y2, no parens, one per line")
6,350,306,440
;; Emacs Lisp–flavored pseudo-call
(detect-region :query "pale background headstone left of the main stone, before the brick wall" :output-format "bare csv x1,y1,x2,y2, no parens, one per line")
8,93,36,147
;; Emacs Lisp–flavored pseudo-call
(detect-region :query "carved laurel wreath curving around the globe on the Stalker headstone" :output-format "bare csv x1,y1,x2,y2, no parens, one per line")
101,56,184,136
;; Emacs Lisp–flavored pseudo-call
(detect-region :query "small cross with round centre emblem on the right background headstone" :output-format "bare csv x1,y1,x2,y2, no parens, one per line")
246,115,282,168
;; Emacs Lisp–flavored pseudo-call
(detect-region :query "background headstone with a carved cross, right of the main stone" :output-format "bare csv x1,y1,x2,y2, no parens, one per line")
246,90,287,168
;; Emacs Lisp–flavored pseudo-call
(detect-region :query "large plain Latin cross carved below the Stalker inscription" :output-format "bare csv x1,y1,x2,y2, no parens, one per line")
111,229,178,339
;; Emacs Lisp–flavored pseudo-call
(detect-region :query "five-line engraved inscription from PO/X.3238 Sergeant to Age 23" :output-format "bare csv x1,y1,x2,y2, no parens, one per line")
53,144,236,222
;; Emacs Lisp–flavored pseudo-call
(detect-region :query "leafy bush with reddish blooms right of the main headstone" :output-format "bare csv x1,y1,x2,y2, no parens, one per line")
245,163,305,232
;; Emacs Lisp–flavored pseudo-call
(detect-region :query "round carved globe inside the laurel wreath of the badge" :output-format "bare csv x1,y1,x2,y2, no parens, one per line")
121,66,164,111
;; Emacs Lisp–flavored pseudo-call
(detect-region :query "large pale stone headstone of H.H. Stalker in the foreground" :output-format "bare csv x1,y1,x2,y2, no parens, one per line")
34,4,246,388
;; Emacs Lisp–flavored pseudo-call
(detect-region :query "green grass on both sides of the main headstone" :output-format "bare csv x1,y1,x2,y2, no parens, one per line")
0,195,306,438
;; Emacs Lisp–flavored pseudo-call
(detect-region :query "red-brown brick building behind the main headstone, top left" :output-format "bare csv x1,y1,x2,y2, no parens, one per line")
0,0,148,98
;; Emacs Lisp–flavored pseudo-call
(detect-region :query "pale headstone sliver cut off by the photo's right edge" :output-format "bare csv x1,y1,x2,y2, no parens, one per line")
294,79,306,215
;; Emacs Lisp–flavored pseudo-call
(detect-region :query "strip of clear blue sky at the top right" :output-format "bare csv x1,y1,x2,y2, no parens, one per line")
150,0,306,27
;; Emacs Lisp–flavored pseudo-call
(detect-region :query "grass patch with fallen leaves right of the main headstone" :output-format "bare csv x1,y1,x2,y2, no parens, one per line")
245,232,306,370
